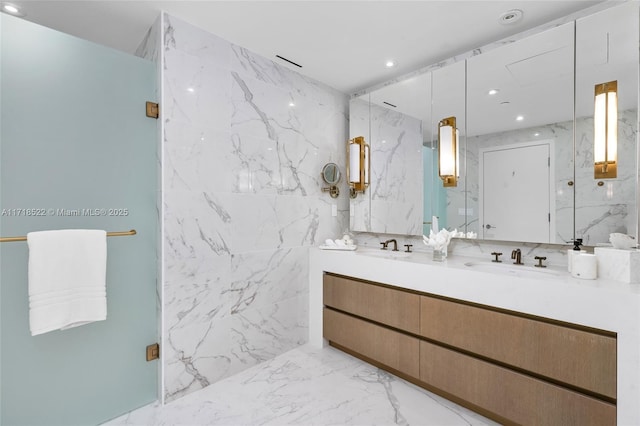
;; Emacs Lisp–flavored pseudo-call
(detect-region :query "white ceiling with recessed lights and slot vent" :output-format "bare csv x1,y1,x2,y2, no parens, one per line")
8,0,602,94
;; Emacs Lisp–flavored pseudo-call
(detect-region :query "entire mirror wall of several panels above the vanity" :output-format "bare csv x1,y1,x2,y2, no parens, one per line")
351,2,640,245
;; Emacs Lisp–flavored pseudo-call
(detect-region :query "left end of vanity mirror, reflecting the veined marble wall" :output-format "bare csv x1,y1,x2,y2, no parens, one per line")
349,74,431,235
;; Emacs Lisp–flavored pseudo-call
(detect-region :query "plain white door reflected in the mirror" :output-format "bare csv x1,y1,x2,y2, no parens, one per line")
479,141,553,243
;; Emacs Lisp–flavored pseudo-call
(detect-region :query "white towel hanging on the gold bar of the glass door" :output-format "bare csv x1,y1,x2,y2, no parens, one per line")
27,229,107,336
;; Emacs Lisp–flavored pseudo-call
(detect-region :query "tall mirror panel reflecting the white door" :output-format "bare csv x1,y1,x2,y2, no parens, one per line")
465,23,574,243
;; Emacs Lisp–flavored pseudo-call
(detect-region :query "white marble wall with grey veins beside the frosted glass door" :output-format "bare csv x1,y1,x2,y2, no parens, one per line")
162,14,348,400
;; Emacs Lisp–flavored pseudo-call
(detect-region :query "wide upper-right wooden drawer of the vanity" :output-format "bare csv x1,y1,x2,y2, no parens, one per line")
420,296,616,399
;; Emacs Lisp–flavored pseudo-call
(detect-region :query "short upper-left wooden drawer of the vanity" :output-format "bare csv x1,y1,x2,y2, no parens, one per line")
323,274,420,334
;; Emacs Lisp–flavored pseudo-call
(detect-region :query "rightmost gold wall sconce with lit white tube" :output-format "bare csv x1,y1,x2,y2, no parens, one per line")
593,80,618,179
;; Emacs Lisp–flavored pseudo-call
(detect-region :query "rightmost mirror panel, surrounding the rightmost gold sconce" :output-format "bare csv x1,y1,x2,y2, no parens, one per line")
575,1,639,245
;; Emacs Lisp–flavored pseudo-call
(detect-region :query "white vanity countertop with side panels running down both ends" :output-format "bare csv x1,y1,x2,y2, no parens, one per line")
309,248,640,425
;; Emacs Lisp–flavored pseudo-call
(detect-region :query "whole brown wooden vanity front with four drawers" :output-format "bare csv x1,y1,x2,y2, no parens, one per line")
323,273,617,426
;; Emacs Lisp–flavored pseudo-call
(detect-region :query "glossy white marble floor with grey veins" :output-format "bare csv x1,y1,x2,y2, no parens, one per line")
106,346,496,426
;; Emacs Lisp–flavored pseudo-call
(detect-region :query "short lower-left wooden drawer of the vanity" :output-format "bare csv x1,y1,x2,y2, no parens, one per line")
323,308,420,377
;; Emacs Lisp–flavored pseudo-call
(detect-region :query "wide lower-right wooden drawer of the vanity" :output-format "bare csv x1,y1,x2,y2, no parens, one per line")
420,341,616,426
